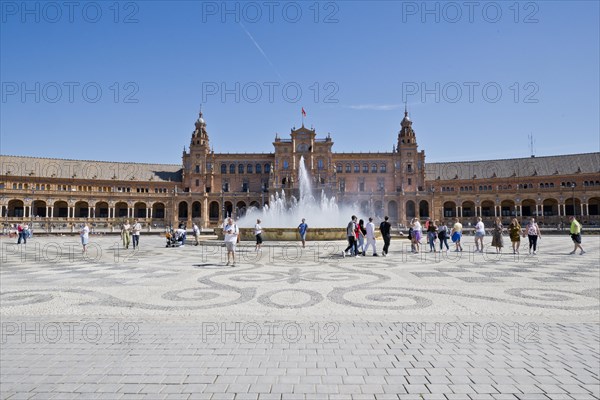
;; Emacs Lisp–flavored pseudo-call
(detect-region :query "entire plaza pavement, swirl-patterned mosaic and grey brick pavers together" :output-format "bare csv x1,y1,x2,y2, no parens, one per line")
0,235,600,400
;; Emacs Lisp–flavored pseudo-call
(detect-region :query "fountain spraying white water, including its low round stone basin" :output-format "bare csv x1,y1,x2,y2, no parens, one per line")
232,156,358,241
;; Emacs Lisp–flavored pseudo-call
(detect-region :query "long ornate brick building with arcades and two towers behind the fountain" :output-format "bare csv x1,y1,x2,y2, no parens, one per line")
0,111,600,229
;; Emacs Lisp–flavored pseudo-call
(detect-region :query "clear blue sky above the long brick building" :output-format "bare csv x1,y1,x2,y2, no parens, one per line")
0,1,600,164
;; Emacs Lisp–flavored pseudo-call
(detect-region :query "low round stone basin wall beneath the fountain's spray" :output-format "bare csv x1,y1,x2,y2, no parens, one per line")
215,227,381,242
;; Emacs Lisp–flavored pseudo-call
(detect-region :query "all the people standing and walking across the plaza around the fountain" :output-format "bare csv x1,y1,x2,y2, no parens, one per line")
11,215,585,260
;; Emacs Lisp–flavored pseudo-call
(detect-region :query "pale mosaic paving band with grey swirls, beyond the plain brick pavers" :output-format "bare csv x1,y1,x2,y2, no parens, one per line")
0,238,600,313
